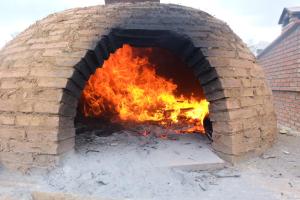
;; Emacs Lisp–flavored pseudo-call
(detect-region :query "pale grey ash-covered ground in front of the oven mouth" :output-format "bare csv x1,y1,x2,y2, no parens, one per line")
0,130,300,200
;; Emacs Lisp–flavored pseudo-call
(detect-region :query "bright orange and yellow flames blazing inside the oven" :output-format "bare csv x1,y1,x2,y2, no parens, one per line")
81,45,209,132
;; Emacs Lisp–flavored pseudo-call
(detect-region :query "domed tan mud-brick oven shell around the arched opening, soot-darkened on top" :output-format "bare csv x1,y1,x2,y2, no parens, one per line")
0,2,277,170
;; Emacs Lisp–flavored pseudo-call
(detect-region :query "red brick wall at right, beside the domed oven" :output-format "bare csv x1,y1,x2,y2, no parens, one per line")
258,24,300,132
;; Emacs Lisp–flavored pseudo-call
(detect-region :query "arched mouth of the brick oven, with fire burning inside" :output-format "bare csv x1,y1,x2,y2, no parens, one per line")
75,44,213,141
